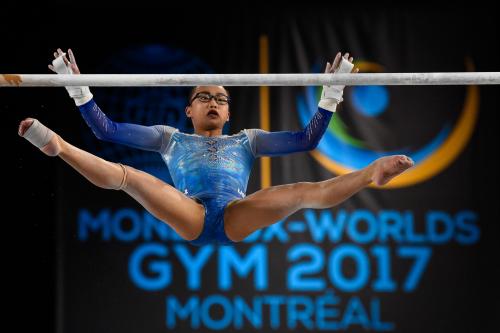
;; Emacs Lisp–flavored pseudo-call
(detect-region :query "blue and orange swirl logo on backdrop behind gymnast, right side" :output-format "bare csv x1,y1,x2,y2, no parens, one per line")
297,61,479,189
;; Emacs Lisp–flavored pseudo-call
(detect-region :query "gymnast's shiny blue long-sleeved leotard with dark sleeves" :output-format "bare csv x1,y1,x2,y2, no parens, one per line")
79,100,332,245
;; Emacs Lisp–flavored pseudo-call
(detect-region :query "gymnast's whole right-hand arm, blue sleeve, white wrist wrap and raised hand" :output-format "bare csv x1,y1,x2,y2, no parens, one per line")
246,53,358,157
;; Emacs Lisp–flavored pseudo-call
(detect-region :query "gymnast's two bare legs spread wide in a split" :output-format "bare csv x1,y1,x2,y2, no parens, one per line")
19,118,413,242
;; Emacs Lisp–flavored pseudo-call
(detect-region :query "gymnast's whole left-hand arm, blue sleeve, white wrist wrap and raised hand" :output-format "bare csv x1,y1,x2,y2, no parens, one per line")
49,49,175,151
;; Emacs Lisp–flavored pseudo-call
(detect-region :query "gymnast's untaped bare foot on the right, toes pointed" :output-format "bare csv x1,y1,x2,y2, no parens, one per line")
372,155,414,186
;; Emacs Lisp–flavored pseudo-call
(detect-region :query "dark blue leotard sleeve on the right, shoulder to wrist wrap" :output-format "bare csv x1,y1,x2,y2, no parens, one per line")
246,108,333,157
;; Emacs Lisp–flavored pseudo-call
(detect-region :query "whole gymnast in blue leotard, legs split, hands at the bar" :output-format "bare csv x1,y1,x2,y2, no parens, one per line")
18,49,413,246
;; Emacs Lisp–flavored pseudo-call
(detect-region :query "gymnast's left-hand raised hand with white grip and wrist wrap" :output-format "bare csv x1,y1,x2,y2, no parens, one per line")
49,49,93,106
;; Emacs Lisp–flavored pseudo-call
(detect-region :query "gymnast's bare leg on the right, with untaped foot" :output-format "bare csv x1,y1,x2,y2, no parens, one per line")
224,155,413,242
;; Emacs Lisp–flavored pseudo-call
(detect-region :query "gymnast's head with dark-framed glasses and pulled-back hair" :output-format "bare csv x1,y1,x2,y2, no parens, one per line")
186,86,229,131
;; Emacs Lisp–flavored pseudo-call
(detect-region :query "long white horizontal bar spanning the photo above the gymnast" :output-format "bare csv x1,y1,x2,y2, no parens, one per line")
0,72,500,87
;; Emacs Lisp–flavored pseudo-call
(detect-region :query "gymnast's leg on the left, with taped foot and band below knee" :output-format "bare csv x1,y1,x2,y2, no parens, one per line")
19,118,205,240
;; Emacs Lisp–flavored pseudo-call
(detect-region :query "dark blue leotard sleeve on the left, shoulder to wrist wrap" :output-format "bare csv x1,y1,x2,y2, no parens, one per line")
78,99,176,152
